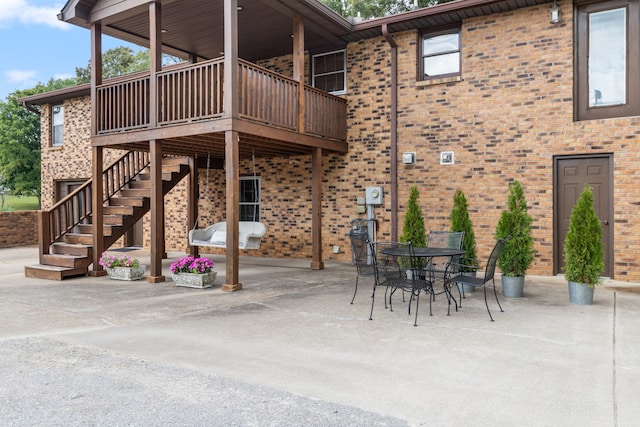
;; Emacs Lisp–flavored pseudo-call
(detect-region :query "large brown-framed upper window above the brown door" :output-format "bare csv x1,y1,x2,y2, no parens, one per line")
576,0,640,120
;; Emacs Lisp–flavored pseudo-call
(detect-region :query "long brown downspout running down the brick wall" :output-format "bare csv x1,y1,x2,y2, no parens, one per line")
382,24,398,242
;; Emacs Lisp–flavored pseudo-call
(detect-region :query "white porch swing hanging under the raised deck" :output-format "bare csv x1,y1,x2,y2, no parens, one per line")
189,153,267,249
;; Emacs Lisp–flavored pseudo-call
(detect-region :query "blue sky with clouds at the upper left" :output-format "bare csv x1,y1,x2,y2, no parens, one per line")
0,0,136,101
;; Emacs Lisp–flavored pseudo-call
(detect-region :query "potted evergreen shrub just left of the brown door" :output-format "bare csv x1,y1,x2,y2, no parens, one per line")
496,181,533,298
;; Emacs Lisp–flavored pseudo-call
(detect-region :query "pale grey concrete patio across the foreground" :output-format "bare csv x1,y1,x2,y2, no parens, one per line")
0,247,640,426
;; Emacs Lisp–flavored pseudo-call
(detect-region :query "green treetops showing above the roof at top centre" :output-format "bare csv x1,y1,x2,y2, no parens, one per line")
322,0,452,19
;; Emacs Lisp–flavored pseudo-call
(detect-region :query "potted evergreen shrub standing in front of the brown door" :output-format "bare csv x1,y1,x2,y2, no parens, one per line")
564,185,604,305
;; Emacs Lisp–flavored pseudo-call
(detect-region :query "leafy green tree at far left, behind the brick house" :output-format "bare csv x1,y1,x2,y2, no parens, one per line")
0,79,75,205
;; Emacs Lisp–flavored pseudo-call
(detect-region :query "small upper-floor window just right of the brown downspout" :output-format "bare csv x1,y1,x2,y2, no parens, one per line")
420,27,460,80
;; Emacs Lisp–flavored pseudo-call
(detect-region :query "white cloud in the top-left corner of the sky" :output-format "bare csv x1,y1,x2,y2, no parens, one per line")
0,0,71,30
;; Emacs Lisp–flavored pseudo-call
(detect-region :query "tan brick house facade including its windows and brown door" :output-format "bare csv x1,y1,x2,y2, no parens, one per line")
21,0,640,281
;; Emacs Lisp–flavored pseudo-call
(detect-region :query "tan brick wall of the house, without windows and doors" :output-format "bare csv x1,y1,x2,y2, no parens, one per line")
38,2,640,281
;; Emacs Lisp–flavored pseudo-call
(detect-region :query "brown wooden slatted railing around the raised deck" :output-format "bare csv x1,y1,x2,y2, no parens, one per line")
96,58,346,140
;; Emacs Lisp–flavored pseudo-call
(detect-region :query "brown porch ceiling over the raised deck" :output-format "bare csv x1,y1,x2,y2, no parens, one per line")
59,0,351,62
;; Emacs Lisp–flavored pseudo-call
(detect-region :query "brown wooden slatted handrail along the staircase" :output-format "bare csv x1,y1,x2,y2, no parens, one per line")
38,151,151,256
